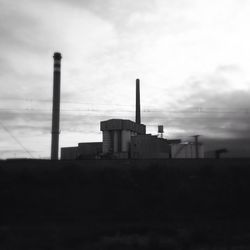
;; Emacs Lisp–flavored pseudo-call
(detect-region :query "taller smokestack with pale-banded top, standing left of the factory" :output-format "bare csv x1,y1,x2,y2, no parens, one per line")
51,52,62,160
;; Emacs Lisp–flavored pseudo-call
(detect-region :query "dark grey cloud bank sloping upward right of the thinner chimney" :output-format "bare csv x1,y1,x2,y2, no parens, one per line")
144,65,250,143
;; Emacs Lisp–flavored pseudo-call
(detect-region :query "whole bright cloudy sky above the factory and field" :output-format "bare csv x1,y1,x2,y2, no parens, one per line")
0,0,250,158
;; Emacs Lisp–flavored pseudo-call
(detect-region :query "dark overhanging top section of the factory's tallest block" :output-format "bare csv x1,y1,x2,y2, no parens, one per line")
100,119,146,134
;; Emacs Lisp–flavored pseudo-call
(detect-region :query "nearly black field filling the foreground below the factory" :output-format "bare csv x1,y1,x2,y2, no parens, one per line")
0,159,250,250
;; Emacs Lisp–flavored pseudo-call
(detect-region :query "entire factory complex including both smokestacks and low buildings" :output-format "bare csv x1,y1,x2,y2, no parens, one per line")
51,52,204,160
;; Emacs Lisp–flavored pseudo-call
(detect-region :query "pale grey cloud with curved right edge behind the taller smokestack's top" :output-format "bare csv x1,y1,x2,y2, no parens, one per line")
0,0,118,100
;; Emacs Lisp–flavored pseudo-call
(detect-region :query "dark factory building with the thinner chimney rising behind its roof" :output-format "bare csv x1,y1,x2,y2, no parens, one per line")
61,79,204,160
